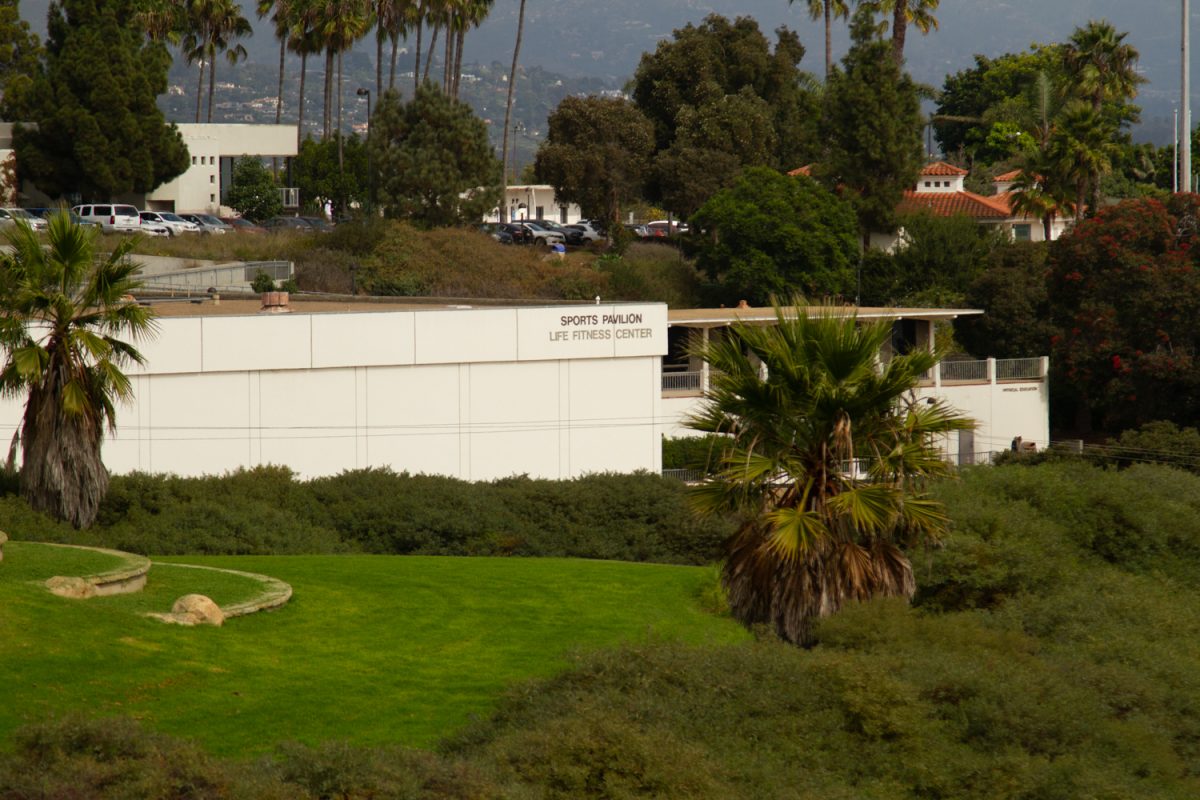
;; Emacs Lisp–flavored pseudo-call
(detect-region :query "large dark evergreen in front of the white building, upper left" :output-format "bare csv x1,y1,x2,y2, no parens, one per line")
13,0,188,199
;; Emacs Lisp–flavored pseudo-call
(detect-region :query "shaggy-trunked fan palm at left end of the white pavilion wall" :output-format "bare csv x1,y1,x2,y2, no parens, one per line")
0,213,154,528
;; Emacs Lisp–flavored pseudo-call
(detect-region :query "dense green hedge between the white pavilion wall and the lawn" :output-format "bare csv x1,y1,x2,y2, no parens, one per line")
0,468,728,564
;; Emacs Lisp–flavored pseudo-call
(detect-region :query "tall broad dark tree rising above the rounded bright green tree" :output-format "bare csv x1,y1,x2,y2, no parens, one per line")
631,14,818,212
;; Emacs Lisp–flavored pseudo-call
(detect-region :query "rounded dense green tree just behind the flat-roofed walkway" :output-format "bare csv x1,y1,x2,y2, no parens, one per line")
691,167,858,305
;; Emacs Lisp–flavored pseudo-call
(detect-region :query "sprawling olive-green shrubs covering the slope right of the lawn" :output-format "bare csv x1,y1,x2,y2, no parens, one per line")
0,461,1200,800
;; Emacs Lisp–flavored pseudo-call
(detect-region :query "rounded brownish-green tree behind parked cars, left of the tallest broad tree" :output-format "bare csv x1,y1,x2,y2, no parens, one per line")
534,97,654,228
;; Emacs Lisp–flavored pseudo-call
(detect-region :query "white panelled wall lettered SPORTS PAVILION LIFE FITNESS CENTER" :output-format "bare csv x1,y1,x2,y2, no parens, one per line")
0,303,666,480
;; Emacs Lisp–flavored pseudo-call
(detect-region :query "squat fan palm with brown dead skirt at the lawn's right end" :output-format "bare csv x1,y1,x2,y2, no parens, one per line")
689,299,973,644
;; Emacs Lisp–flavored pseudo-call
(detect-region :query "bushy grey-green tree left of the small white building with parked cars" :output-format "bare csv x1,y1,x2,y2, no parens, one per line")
368,84,500,227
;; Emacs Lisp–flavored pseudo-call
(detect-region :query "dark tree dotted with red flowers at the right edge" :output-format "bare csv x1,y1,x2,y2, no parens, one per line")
1048,194,1200,432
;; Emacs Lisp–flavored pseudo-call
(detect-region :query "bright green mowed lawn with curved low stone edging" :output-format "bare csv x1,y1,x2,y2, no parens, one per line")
0,542,746,756
